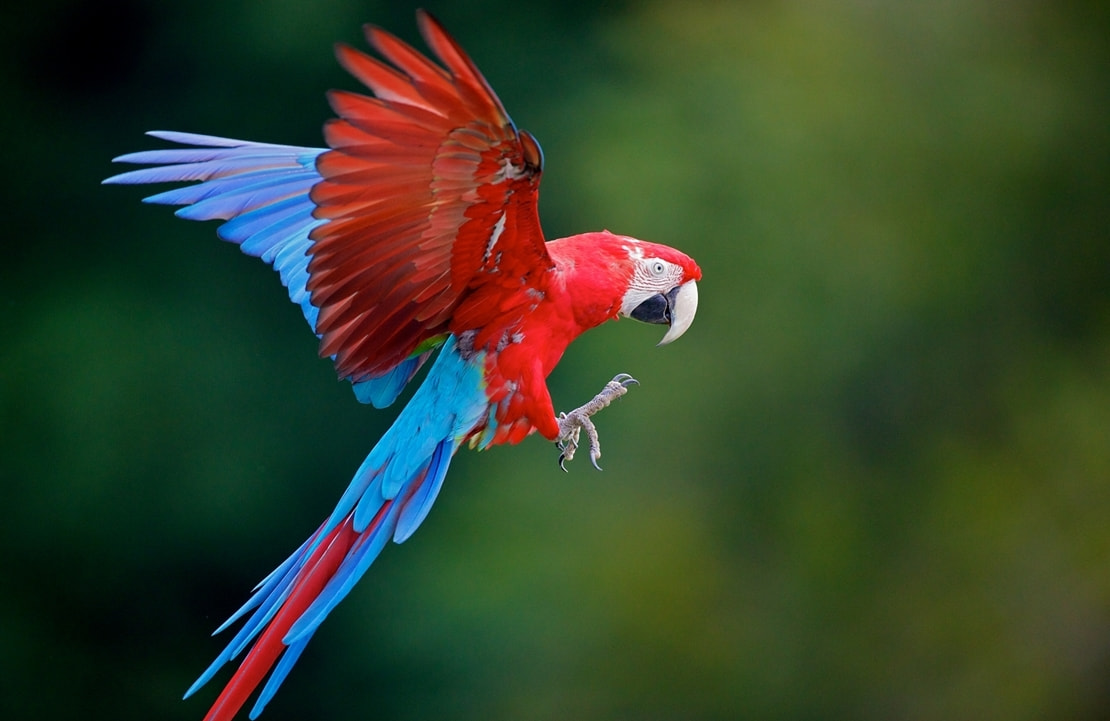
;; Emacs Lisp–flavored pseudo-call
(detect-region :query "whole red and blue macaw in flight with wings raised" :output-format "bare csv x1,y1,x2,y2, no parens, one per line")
104,12,702,721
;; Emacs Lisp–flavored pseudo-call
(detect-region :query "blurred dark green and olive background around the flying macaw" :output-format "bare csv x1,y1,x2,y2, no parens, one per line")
0,0,1110,721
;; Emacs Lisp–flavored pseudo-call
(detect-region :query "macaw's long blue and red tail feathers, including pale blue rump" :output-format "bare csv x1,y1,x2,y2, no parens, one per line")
185,338,488,721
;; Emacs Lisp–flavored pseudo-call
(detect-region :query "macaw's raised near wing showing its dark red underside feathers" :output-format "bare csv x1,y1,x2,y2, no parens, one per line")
307,12,552,382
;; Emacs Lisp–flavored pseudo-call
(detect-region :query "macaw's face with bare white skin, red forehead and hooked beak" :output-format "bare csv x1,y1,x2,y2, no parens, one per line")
620,238,702,345
